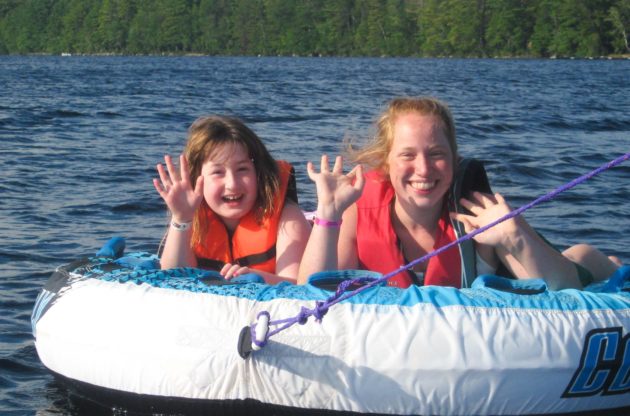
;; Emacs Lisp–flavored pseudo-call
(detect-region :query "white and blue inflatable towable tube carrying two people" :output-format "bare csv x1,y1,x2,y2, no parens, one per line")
32,239,630,415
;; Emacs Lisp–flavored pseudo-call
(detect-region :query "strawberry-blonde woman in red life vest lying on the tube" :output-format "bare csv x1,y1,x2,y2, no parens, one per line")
298,98,616,290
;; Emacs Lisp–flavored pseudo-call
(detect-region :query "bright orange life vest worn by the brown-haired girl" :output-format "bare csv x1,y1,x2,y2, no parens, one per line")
193,161,293,273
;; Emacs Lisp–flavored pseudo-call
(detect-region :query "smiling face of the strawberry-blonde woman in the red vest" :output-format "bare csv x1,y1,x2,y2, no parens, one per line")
387,112,453,213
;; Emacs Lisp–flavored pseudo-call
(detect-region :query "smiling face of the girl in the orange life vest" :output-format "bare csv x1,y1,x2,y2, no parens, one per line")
201,144,258,231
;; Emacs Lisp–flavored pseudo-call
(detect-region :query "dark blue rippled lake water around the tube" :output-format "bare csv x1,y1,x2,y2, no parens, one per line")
0,57,630,415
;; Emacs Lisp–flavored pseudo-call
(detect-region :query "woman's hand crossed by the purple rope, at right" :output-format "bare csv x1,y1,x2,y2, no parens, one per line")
450,192,522,247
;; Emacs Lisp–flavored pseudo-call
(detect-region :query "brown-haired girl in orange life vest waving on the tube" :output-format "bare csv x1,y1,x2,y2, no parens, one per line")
153,116,310,284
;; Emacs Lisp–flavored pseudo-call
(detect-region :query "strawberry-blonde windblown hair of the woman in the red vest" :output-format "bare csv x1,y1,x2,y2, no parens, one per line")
347,97,457,174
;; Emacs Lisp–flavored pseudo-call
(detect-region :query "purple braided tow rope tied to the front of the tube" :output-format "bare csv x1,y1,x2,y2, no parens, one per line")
260,153,630,339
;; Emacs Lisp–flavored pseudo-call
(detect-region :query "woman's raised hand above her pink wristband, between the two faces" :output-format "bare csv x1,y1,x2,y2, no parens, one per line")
306,155,365,221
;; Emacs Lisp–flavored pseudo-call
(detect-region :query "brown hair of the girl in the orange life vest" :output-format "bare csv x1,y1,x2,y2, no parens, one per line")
184,116,280,245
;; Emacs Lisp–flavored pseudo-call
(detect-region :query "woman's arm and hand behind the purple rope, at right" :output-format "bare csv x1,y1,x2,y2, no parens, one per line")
451,192,582,290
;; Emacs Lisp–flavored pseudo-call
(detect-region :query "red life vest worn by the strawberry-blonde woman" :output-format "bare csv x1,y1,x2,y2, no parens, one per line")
357,171,462,288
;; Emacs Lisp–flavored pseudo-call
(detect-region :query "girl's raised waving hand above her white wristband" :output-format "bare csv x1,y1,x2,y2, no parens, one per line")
153,155,203,222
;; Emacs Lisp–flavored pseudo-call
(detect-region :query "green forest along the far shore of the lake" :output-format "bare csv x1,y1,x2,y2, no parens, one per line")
0,0,630,57
